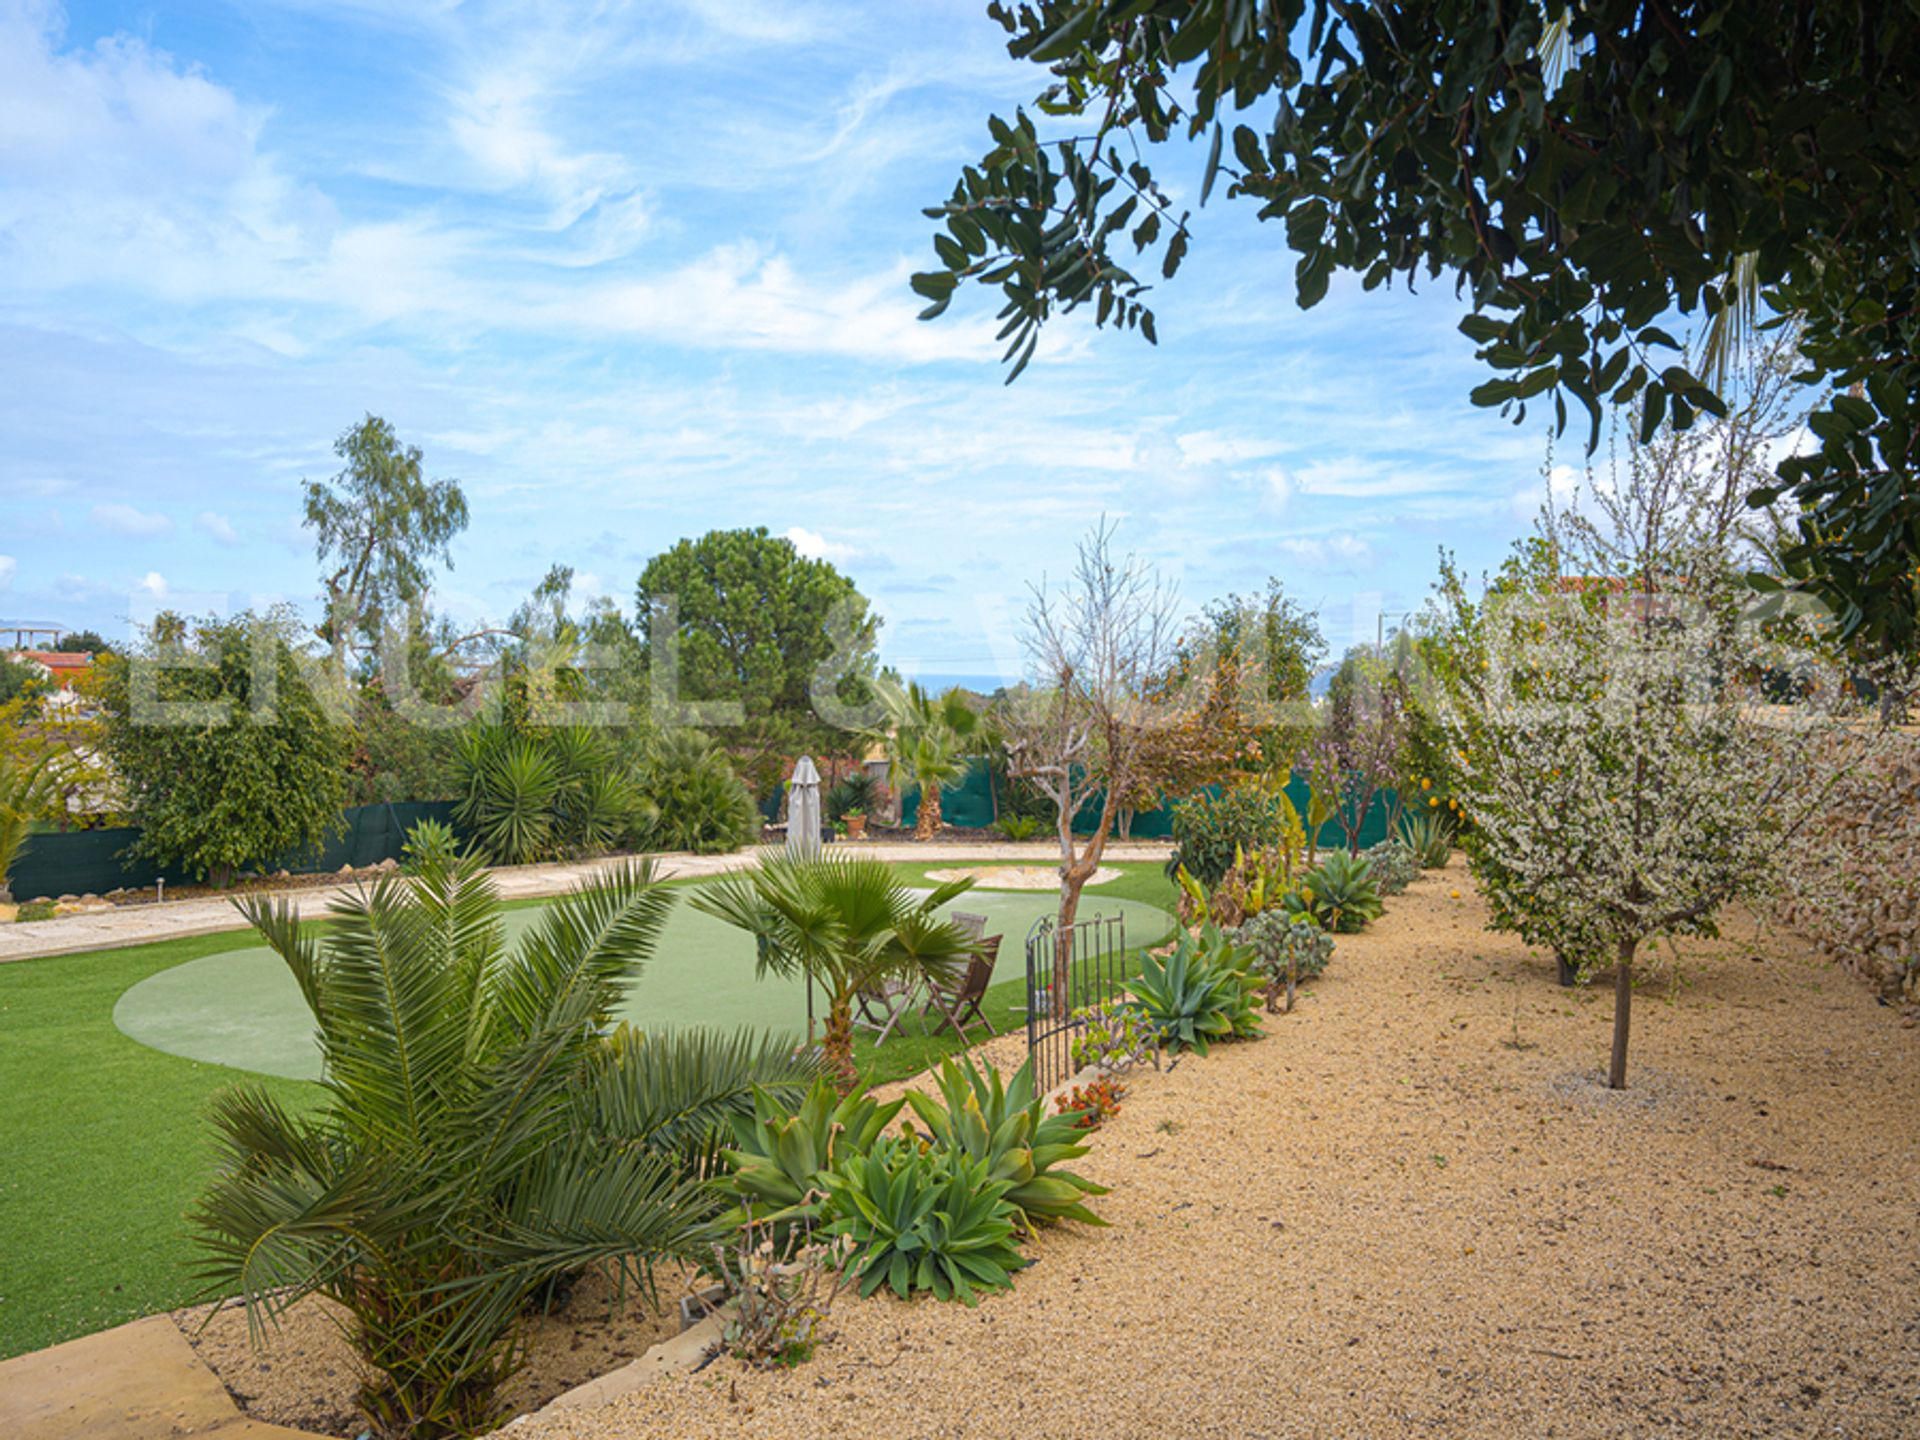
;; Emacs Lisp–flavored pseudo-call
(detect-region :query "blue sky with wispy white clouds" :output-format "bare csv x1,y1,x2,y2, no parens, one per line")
0,0,1546,676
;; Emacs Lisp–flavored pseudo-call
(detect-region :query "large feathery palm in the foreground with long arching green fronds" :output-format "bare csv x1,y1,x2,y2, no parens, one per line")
194,858,818,1440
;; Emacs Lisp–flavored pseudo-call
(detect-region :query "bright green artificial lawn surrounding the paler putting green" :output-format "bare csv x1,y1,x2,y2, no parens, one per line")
0,862,1173,1357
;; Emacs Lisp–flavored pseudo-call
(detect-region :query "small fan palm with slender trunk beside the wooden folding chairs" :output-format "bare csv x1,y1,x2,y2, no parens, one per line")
691,854,977,1092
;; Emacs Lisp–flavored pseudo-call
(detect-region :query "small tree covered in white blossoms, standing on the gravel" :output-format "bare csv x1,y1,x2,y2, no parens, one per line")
1425,476,1878,1089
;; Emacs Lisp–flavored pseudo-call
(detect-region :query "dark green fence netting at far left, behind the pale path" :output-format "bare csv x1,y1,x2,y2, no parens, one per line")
10,801,464,900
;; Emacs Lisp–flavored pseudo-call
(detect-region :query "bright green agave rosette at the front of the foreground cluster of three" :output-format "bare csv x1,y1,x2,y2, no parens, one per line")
826,1135,1027,1306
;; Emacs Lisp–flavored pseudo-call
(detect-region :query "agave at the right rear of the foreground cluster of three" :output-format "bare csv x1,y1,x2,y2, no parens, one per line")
906,1056,1106,1229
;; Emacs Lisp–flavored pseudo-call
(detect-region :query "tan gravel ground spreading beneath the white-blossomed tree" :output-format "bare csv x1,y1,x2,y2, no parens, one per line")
495,866,1920,1440
